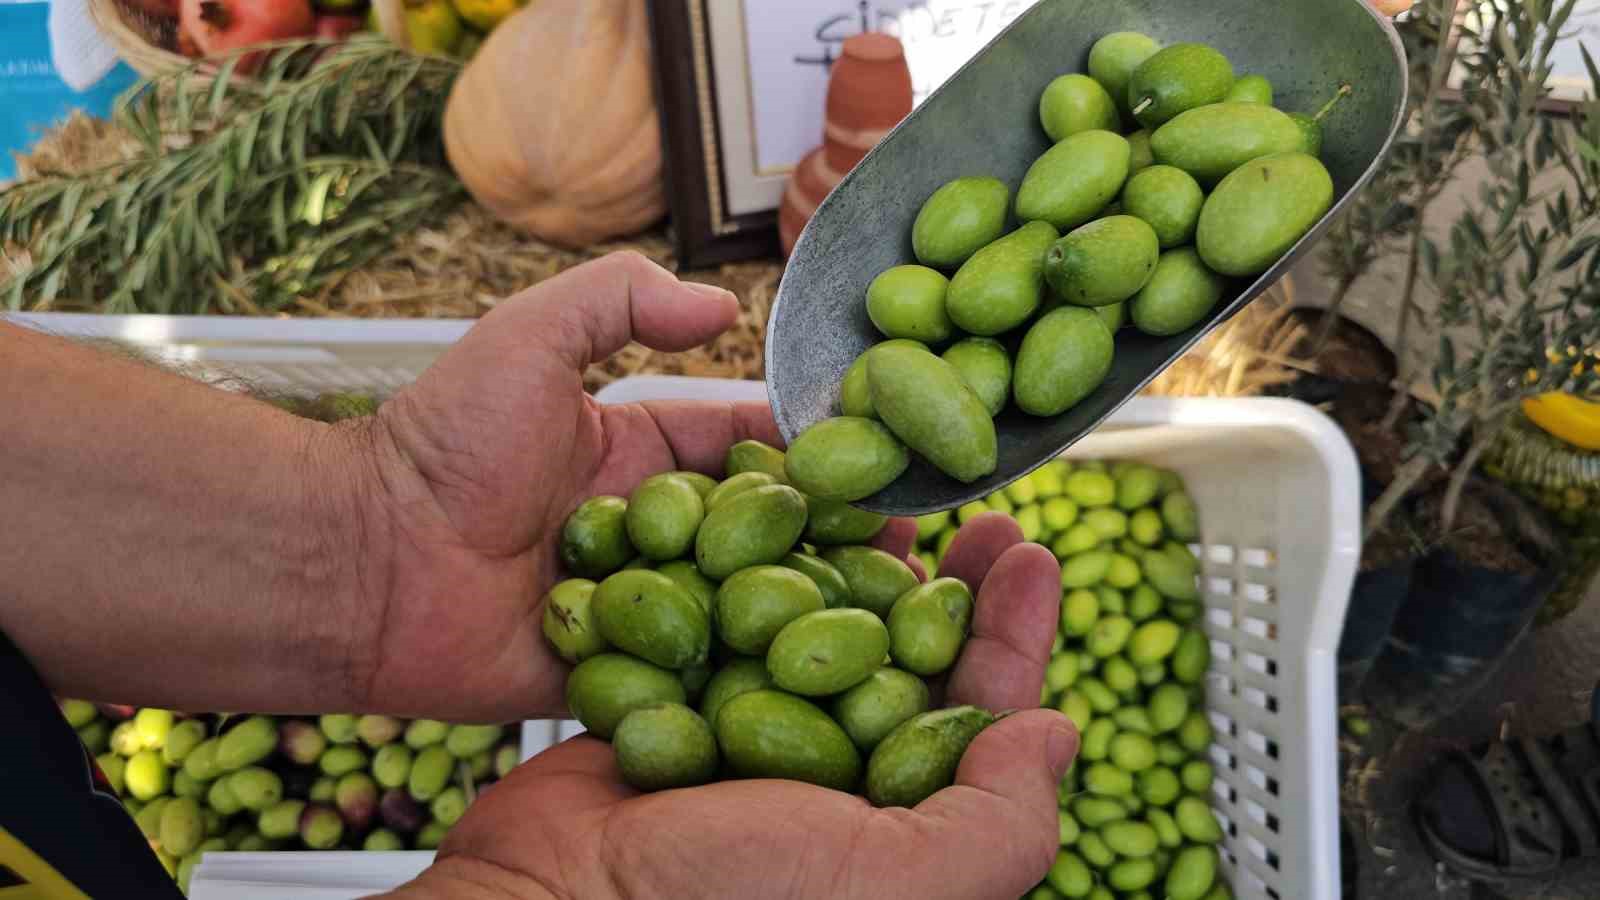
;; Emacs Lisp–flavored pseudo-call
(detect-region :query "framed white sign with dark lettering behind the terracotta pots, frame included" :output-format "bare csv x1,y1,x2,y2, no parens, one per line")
650,0,1037,267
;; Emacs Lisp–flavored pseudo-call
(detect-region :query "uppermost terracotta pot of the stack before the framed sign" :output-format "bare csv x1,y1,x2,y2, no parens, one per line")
822,32,912,171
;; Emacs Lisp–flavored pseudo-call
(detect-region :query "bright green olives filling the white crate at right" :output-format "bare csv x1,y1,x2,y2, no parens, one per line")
908,460,1230,898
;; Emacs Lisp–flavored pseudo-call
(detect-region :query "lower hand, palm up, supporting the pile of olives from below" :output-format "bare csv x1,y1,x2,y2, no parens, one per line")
379,512,1078,900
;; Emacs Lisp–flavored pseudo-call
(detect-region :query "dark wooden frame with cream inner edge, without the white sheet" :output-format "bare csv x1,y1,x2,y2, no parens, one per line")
650,0,779,269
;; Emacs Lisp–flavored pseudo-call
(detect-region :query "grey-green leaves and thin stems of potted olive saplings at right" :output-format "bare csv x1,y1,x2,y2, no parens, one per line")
1363,0,1600,533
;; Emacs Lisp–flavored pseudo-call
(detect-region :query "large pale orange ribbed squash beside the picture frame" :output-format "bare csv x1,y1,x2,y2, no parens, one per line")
445,0,666,247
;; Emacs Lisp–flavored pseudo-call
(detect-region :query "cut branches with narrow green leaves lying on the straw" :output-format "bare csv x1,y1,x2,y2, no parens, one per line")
0,38,464,314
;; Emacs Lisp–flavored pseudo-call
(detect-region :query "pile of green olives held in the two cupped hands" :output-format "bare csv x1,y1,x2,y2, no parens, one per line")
544,440,994,807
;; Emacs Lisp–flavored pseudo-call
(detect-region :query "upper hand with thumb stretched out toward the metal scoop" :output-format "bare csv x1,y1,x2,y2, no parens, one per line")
332,253,787,722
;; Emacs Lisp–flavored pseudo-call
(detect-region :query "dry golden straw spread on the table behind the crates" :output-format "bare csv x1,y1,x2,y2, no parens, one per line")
18,114,1307,397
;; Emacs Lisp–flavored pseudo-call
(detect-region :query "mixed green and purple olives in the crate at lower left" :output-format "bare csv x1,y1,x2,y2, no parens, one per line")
59,700,520,892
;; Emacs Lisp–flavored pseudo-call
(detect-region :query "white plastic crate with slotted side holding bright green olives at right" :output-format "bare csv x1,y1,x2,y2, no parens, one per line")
592,376,1362,900
